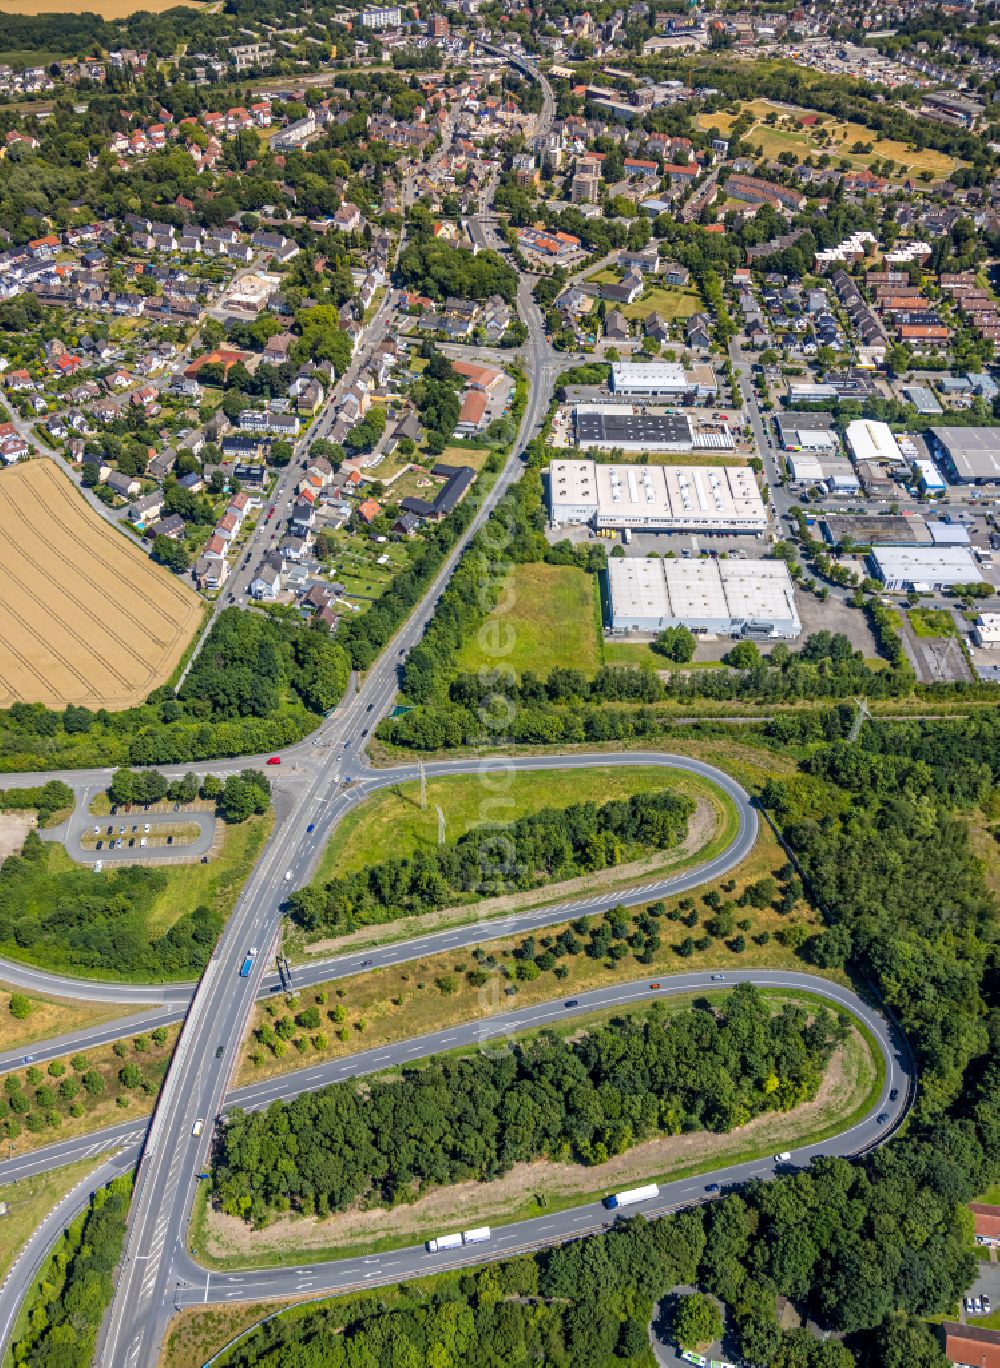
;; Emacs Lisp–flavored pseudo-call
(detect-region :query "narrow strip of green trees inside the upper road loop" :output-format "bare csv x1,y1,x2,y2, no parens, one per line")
289,789,695,934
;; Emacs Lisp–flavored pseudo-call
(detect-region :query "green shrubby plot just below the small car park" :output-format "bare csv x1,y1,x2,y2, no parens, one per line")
0,832,223,982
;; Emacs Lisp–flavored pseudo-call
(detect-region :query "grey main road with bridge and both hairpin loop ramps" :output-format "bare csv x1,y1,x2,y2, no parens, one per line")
0,53,912,1368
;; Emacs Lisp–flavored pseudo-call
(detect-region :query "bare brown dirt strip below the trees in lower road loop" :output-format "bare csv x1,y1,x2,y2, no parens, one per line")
207,1030,869,1259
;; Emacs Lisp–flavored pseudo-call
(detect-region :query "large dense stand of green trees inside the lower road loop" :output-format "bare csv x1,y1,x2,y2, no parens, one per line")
213,984,847,1224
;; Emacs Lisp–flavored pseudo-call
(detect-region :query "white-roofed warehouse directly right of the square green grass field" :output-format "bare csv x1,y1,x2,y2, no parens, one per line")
607,557,802,639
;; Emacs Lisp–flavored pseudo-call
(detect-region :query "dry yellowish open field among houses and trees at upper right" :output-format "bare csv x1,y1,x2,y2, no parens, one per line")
696,100,959,181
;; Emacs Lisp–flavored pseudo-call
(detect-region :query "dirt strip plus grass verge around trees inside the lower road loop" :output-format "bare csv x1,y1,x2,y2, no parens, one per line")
199,990,885,1270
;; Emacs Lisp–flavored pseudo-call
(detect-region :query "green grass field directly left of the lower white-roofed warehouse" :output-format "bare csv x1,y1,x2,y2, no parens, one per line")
458,561,601,677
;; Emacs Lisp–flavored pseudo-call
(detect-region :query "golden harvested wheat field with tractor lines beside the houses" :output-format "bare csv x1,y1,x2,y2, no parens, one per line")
0,460,201,709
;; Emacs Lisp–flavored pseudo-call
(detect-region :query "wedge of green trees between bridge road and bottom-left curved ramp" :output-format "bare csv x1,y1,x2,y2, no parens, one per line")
12,1174,131,1368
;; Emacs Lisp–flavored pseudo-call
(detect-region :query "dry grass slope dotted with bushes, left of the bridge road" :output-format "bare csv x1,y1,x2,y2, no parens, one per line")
0,1026,179,1157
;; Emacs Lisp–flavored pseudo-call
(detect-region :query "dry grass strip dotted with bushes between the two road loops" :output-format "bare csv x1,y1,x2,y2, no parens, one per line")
251,826,815,1085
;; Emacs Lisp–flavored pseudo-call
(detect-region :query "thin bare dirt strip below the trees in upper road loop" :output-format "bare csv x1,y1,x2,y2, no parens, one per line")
296,798,722,955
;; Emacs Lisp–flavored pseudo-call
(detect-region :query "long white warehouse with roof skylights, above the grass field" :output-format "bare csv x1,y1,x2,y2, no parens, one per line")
549,461,767,536
